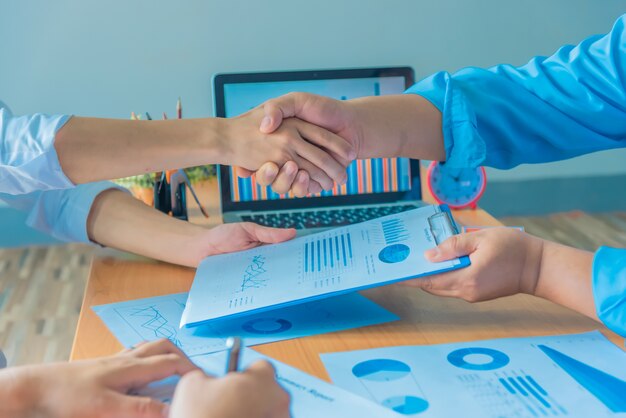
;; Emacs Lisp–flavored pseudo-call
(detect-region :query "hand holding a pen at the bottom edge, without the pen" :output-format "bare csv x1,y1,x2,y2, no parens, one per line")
170,361,289,418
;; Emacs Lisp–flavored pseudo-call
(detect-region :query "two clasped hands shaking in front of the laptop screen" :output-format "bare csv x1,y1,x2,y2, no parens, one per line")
227,93,361,197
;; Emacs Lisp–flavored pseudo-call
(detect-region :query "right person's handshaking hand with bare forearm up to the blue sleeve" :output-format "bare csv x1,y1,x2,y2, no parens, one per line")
251,93,446,195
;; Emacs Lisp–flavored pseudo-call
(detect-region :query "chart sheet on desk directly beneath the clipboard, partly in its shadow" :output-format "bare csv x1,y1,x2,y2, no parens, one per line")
93,293,398,356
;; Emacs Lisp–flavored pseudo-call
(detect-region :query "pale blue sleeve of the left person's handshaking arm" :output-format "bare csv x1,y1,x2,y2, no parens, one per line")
0,102,74,195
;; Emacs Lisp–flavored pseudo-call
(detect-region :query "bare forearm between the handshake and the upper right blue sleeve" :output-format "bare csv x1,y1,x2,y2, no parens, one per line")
349,94,446,161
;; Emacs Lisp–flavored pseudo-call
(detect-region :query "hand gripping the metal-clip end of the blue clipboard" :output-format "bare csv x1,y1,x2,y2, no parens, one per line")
403,228,543,302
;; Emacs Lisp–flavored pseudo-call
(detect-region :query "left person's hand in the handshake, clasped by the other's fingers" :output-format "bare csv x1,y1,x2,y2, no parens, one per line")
224,108,356,190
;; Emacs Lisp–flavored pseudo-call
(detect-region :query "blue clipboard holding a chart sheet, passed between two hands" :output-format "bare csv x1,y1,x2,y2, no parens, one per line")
181,205,469,327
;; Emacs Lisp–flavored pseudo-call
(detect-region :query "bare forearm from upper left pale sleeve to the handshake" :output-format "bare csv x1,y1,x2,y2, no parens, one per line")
55,117,226,184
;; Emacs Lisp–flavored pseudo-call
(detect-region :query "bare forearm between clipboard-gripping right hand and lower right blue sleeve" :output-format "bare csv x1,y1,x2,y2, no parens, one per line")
534,241,598,320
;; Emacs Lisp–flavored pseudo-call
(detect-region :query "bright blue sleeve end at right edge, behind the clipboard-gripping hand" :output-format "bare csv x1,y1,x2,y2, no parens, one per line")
592,247,626,337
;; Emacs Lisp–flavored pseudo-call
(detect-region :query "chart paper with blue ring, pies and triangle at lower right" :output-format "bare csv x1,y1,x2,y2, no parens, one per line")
321,332,626,418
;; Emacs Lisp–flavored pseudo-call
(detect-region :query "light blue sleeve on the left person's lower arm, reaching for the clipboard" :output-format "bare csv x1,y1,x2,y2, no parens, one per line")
0,182,126,243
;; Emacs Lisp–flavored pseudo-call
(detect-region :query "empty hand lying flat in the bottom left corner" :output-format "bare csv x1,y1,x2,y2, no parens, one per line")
0,340,197,418
